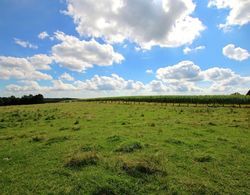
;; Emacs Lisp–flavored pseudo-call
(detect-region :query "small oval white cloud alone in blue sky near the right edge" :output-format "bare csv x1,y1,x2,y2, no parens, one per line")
223,44,250,61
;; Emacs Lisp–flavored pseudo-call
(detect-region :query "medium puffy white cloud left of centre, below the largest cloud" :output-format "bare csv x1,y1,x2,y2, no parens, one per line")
52,32,124,72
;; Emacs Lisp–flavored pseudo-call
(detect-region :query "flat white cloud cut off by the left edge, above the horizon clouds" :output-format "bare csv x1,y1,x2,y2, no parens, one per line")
0,55,52,80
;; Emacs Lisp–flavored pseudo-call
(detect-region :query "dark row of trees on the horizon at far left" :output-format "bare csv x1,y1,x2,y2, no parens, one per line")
0,94,44,106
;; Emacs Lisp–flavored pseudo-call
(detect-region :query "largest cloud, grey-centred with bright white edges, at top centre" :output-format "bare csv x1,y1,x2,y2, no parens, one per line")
64,0,205,49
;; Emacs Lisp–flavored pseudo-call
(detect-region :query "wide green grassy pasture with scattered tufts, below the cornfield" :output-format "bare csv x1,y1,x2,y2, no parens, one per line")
0,102,250,194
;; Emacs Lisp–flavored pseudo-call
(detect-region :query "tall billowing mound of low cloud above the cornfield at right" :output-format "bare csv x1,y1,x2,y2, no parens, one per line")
152,61,250,93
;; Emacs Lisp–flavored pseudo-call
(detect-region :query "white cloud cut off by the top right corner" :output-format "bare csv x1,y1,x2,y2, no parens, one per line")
208,0,250,30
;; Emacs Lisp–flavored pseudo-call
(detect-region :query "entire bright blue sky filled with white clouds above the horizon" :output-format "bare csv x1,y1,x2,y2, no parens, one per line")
0,0,250,98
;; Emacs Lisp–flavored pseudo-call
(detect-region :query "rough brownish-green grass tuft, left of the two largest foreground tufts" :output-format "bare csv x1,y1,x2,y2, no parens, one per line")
64,152,99,169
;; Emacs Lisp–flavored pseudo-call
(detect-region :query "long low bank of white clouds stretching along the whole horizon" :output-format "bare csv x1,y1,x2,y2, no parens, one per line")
3,61,250,97
